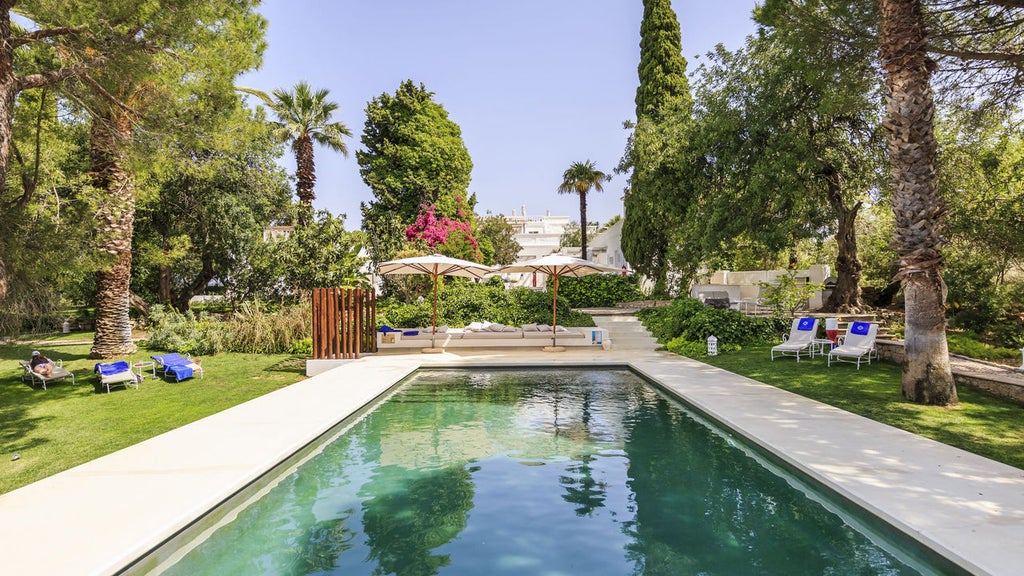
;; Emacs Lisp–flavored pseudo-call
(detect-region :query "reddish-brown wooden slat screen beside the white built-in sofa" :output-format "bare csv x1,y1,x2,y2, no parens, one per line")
312,288,377,360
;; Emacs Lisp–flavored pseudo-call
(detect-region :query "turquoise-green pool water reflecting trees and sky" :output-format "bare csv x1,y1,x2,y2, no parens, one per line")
157,370,943,576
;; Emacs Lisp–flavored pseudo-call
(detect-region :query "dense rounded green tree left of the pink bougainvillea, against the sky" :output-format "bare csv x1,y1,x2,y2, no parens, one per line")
355,80,476,261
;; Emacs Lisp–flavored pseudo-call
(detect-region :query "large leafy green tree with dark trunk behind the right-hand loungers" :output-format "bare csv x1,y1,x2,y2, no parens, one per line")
675,12,883,312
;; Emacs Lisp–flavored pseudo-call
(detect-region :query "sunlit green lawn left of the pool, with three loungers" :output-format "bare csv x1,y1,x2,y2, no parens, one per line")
0,344,304,493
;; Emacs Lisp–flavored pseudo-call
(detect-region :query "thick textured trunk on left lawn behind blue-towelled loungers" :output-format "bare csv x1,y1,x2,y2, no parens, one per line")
89,113,136,358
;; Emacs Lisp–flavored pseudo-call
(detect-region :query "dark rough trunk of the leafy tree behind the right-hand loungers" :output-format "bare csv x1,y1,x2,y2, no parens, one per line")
822,170,864,314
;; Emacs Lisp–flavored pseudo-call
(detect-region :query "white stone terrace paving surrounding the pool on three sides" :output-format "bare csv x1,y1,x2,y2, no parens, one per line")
0,342,1024,576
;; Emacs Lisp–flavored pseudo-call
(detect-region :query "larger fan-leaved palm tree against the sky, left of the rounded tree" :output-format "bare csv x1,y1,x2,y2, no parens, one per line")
247,82,352,225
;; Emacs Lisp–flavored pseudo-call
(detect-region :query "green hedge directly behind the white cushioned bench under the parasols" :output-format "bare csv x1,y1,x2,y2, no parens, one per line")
377,280,594,328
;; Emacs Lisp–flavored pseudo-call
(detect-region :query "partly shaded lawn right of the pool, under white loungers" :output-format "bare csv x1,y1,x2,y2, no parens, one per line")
698,345,1024,468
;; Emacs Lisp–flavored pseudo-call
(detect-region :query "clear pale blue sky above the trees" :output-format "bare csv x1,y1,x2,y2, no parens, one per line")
239,0,755,230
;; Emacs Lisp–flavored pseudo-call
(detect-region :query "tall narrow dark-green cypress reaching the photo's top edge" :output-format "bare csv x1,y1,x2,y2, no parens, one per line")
618,0,692,293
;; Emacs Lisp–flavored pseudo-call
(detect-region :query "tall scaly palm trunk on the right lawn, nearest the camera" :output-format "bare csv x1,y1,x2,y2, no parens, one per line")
879,0,957,405
